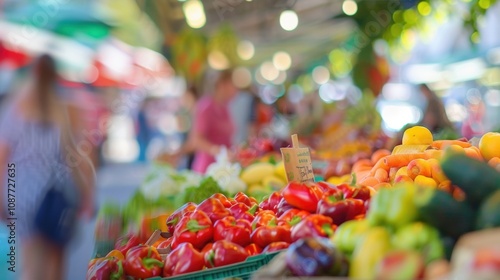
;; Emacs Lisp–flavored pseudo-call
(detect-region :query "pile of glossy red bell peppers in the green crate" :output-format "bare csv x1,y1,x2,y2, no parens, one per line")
87,182,372,279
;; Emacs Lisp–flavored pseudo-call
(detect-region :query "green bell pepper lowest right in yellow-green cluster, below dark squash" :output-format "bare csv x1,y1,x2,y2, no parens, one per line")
392,222,445,264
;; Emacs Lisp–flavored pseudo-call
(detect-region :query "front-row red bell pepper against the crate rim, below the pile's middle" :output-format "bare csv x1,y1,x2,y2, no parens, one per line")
205,240,248,267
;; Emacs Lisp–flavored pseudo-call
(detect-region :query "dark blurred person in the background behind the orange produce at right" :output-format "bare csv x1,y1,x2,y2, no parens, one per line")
419,84,455,133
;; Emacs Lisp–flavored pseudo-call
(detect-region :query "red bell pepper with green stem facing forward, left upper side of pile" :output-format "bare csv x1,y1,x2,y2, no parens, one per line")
171,210,214,249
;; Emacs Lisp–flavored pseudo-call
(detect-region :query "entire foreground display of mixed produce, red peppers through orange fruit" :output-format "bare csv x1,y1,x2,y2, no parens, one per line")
87,126,500,279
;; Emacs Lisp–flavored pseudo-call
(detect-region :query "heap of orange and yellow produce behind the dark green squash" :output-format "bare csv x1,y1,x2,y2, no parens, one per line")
326,126,498,197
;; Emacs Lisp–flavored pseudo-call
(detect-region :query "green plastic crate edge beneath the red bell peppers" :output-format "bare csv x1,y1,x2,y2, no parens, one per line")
148,251,281,280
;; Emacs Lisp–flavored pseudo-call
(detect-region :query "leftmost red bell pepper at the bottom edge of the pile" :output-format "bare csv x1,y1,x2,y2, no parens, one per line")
86,257,125,280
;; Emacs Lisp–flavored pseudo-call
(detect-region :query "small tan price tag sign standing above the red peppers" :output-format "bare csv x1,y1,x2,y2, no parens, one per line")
281,134,314,183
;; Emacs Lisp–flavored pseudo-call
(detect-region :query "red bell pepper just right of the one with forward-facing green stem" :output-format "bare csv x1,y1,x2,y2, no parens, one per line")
214,216,252,246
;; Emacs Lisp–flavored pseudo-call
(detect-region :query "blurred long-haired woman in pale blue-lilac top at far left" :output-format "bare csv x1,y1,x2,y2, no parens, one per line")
0,55,95,280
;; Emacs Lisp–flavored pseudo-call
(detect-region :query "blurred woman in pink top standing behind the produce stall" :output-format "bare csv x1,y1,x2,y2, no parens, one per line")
180,70,237,173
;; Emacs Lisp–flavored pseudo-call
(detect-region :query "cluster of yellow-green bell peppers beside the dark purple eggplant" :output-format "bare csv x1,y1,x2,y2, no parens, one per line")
331,185,445,279
